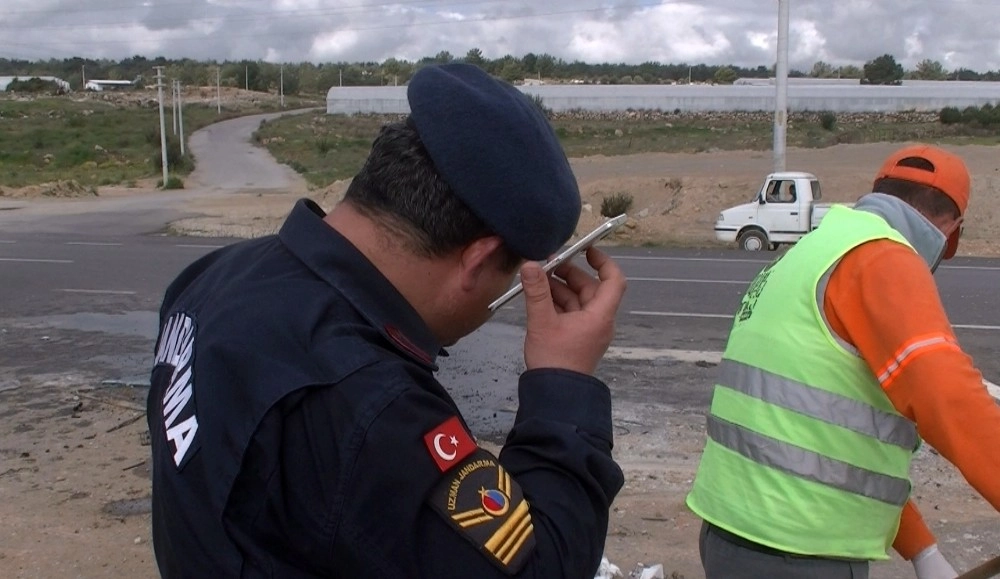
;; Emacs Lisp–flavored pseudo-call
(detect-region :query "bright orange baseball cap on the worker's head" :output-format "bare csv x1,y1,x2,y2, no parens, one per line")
875,145,970,259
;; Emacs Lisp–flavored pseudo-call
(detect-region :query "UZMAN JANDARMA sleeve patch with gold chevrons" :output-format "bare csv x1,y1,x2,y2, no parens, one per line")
429,448,535,575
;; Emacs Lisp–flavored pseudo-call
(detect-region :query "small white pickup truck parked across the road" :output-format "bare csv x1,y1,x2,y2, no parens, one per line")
715,171,844,251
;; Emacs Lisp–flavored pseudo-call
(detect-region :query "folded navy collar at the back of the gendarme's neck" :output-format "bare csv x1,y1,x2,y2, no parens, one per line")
278,199,441,370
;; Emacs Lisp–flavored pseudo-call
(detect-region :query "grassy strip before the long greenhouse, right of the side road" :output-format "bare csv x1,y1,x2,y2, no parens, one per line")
255,112,1000,187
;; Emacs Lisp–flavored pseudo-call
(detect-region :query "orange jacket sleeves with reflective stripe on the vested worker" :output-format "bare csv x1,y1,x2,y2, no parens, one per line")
823,240,1000,559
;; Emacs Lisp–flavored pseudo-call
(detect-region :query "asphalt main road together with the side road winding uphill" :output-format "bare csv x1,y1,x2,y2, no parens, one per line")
0,109,1000,446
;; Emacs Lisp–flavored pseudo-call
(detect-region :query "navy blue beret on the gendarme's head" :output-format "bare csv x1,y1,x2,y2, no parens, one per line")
406,64,580,260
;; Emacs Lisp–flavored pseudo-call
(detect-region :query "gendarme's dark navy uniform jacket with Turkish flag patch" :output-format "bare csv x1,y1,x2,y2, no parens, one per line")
148,201,623,579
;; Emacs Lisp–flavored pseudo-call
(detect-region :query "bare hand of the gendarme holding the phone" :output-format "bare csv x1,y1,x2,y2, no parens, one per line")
521,247,625,374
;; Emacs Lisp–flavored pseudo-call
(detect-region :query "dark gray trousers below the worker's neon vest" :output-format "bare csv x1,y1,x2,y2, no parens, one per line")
698,523,868,579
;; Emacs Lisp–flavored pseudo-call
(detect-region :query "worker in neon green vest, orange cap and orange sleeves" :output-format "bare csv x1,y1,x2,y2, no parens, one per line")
687,145,1000,579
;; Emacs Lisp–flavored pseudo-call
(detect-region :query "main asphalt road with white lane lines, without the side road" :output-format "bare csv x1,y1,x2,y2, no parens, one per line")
0,227,1000,437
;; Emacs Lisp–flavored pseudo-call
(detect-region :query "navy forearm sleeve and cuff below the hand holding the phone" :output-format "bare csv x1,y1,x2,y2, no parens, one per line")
500,369,624,577
